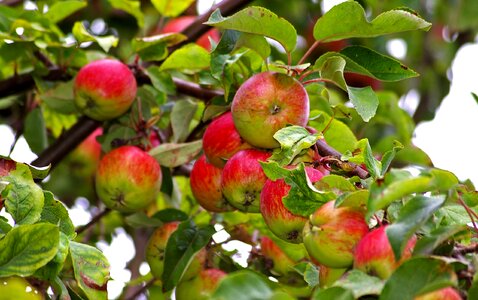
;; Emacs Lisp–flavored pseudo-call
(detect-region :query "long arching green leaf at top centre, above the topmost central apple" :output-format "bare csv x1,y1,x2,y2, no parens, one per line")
205,6,297,52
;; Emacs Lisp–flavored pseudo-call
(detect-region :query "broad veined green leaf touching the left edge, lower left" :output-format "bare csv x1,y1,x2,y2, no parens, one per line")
0,223,60,277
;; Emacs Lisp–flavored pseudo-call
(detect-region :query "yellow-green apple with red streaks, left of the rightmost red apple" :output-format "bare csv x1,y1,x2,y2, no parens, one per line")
303,201,368,268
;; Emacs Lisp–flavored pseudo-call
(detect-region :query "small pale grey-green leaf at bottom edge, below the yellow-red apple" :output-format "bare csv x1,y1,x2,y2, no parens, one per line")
334,270,384,299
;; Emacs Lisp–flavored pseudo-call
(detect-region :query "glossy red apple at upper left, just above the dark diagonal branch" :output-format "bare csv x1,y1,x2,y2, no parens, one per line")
73,59,137,121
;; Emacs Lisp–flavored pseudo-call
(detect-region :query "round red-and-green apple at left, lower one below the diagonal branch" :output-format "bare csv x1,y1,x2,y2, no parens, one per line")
95,146,162,212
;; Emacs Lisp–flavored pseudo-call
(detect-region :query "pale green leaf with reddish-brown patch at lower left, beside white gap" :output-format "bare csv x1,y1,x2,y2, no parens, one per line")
70,241,110,299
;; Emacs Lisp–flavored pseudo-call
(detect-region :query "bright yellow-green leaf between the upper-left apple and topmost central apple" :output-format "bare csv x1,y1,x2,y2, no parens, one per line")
159,43,211,72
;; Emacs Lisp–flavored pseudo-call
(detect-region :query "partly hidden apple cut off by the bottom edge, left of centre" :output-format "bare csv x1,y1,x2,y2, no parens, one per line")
175,269,227,300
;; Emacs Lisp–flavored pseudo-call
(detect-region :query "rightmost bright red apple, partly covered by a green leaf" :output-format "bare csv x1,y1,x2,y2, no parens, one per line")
354,225,417,279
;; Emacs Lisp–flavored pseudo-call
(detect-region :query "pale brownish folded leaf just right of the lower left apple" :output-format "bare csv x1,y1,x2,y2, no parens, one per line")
149,140,202,168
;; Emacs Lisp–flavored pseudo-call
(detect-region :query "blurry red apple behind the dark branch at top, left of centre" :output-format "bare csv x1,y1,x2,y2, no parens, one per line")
151,16,220,51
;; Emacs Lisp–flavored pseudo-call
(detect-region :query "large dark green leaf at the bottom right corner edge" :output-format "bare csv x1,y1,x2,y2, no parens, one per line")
379,257,456,300
